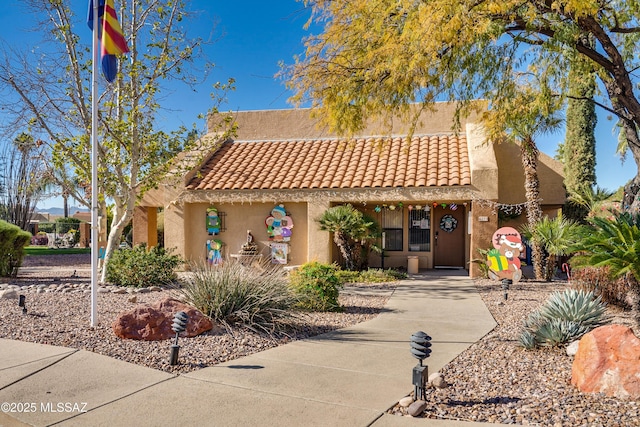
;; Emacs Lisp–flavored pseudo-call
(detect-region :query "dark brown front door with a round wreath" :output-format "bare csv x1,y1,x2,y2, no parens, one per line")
433,205,465,268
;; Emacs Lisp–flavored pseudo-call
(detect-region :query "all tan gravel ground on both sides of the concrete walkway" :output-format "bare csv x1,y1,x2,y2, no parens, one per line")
5,256,640,427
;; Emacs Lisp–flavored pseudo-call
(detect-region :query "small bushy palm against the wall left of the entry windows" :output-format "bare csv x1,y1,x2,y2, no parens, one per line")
317,204,374,270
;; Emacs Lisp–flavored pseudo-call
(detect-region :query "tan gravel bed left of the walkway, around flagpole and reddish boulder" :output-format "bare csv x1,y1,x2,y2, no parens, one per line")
0,255,395,373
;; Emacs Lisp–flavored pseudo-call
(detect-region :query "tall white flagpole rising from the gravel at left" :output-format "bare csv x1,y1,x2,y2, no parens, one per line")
91,0,100,327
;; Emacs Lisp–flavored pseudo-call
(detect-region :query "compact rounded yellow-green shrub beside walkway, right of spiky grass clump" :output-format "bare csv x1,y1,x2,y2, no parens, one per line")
289,261,342,311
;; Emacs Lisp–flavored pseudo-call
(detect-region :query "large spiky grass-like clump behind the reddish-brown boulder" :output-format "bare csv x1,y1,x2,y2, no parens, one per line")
181,261,296,332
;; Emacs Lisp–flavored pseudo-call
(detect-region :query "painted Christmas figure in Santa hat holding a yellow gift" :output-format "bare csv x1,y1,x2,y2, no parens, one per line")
487,227,524,282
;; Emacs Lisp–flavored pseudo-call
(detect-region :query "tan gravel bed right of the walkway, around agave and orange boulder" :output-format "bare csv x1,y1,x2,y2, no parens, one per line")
391,280,640,427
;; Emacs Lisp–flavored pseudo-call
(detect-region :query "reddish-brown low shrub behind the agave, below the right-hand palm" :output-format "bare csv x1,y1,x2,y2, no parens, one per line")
571,266,638,309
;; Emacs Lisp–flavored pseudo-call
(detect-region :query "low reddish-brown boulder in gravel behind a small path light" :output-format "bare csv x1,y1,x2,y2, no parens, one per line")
112,297,218,341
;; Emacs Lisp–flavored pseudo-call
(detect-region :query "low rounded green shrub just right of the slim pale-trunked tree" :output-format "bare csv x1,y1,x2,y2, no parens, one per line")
106,244,182,288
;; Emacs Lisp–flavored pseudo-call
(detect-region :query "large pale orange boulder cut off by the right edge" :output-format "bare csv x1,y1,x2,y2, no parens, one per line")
571,325,640,399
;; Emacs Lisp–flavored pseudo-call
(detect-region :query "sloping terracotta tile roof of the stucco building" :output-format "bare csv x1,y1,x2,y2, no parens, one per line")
186,135,471,190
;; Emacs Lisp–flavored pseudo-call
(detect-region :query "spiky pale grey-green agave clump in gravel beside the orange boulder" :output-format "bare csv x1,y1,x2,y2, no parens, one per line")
518,289,606,350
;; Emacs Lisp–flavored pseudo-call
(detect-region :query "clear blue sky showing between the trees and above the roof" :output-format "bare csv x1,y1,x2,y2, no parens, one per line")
0,0,636,208
